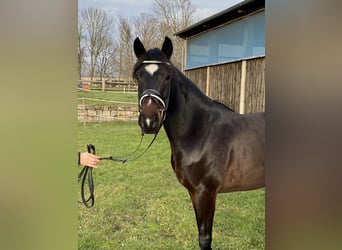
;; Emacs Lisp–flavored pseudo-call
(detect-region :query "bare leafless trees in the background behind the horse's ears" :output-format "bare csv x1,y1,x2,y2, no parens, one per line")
78,0,196,80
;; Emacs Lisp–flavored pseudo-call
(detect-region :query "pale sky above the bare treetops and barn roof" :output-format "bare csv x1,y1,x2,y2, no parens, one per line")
78,0,242,21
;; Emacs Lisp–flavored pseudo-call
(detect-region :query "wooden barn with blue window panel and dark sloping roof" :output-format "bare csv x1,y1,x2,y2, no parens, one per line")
175,0,265,114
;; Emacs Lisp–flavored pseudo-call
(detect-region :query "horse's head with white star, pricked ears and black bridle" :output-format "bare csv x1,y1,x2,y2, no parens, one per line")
133,37,173,134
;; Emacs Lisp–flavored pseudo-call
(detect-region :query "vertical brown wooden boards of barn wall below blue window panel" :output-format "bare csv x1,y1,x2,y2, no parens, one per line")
185,56,265,114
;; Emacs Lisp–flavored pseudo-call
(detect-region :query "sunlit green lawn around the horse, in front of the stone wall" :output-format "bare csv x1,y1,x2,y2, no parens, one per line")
78,122,265,250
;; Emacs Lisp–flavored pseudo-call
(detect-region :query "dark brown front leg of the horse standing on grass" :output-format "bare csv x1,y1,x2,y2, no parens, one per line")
189,189,217,250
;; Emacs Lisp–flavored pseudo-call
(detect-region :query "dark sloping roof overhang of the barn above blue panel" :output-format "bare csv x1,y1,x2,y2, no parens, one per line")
175,0,265,39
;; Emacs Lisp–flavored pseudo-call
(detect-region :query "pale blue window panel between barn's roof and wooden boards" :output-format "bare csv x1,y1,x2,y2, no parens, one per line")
186,11,265,69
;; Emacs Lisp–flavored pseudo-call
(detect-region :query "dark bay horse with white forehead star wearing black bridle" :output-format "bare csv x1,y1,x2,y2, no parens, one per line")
133,37,265,250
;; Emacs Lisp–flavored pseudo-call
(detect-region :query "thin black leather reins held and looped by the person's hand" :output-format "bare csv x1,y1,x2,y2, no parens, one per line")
78,133,158,208
